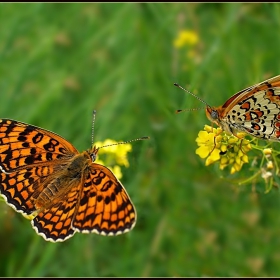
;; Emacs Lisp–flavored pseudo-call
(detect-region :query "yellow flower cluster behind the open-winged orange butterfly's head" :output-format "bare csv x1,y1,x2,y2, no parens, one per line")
95,139,132,179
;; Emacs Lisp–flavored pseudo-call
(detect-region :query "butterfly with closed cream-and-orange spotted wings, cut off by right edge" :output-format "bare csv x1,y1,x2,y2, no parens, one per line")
174,75,280,141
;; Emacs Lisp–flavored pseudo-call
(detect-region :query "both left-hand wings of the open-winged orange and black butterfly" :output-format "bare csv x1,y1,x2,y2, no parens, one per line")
0,119,78,215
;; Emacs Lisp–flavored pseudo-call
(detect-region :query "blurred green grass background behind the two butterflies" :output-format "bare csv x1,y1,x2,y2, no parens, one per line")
0,3,280,277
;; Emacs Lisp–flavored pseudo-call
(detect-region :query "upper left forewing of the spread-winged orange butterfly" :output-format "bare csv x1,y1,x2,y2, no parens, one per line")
0,119,78,172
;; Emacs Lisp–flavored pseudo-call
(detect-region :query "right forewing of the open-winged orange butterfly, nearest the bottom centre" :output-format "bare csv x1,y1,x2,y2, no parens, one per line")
73,163,136,235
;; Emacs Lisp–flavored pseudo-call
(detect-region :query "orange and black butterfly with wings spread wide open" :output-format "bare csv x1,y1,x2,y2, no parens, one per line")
0,116,148,242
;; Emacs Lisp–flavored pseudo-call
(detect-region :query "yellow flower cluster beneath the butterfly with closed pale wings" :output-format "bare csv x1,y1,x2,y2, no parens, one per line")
196,125,251,174
